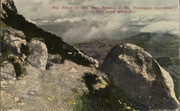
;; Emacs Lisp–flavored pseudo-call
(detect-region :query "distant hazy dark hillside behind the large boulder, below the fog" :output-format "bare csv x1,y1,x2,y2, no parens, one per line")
75,33,180,98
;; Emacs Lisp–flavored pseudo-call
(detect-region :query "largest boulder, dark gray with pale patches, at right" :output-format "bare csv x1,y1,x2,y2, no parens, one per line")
101,43,179,110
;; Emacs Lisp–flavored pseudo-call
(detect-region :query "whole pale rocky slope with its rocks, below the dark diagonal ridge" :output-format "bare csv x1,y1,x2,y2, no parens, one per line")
1,22,107,111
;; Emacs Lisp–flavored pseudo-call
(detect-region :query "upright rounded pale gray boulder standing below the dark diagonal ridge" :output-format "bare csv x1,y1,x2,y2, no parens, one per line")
28,39,48,70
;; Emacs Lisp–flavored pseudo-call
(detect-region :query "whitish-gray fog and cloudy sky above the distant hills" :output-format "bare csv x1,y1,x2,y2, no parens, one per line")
14,0,179,43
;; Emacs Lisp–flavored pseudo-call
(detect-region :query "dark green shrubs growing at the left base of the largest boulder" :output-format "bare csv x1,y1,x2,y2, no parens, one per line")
72,73,138,111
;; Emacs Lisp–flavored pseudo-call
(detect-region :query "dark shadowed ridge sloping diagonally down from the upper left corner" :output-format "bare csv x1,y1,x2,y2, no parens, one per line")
1,4,99,67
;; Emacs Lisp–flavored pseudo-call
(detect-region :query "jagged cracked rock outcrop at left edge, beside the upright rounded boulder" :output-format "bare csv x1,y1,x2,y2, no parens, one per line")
0,23,27,77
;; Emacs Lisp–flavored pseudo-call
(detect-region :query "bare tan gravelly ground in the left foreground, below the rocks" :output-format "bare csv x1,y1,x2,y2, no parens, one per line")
0,60,96,111
